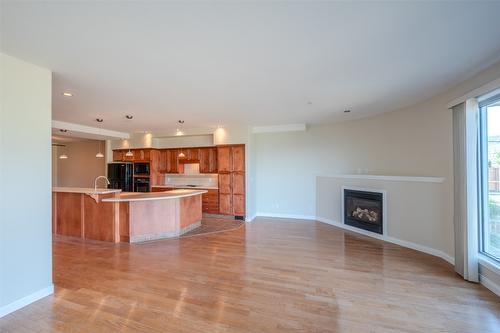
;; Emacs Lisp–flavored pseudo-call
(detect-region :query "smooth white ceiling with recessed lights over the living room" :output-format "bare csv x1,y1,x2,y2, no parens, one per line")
1,1,500,132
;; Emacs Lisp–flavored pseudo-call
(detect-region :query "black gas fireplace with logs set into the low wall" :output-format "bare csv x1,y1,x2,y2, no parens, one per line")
343,189,384,234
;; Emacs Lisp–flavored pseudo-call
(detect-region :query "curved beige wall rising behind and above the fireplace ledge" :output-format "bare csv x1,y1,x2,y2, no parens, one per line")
255,59,500,257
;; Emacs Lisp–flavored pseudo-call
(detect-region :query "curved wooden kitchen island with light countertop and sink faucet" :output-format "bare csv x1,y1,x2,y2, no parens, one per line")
52,187,206,243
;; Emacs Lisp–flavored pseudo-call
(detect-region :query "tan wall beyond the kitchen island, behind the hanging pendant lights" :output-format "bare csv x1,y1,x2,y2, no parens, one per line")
55,140,106,187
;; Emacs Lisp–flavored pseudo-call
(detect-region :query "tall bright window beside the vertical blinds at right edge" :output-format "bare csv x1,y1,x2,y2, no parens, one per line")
479,95,500,261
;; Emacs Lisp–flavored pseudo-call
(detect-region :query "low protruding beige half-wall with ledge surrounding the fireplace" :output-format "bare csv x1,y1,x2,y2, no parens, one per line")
316,177,453,262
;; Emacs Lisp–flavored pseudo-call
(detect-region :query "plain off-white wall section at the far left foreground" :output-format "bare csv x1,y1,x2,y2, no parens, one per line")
0,53,53,317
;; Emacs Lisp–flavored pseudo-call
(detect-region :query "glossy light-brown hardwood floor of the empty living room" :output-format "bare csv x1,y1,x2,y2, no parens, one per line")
0,218,500,333
